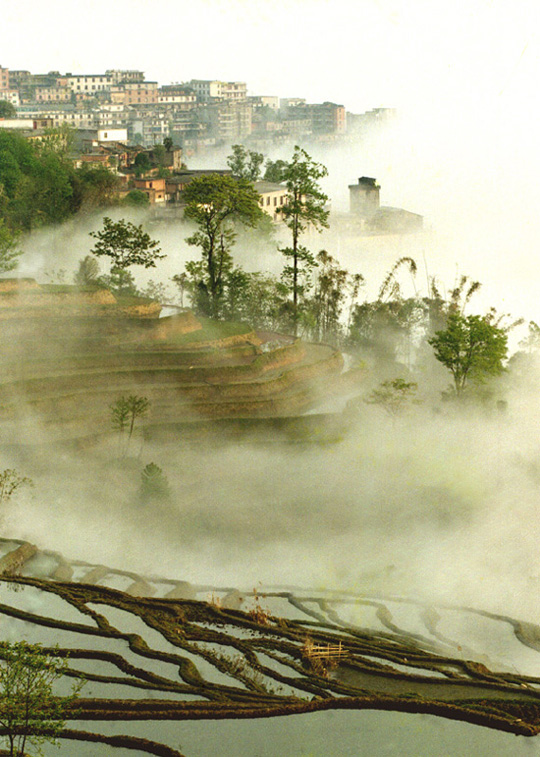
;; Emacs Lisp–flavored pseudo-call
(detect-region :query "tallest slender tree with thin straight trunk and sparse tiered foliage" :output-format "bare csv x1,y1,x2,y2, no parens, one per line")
280,146,329,334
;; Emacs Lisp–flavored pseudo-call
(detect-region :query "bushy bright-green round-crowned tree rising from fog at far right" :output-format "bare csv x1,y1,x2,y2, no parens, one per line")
428,312,508,397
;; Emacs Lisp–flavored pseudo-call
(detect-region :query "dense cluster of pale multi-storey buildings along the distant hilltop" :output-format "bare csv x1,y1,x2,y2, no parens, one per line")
0,66,391,155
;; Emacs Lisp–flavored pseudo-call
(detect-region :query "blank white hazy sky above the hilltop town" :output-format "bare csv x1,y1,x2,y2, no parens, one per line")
4,0,540,111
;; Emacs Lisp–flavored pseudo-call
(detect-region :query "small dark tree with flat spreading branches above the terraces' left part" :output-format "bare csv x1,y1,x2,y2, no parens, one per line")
90,217,165,289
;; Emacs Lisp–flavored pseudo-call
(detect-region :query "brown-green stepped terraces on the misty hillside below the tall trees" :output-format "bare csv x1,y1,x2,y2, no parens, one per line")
0,290,343,440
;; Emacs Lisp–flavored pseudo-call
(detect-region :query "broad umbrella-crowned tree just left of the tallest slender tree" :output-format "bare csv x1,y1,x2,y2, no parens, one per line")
183,174,263,318
